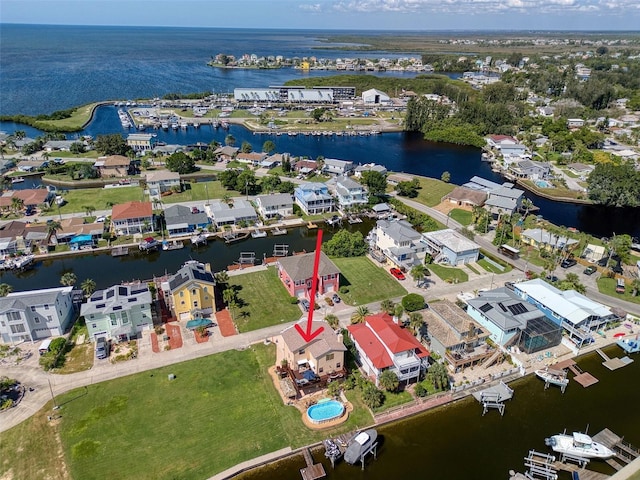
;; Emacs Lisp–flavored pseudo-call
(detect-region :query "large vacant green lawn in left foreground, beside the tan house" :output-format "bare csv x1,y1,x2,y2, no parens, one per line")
0,345,372,480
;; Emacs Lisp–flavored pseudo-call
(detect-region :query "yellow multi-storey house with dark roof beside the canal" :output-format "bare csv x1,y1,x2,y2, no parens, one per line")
163,260,216,320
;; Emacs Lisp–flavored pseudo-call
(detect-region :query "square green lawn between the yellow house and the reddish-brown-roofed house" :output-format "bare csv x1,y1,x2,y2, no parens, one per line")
229,267,302,332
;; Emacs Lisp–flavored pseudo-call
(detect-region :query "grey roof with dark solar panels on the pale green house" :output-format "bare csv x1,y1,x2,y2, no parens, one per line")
80,283,152,315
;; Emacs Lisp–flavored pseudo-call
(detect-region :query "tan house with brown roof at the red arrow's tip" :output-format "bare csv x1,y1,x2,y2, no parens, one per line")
273,320,347,377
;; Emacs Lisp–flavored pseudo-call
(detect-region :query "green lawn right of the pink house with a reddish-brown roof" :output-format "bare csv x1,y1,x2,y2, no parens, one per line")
331,257,409,305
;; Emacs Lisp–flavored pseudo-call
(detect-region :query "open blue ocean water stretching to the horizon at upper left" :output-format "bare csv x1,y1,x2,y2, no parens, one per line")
0,24,424,115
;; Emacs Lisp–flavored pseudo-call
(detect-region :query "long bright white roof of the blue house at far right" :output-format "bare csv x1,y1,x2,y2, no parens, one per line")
515,278,613,325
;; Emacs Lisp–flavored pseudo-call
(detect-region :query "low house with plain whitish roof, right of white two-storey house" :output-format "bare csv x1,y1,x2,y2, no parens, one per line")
422,228,480,266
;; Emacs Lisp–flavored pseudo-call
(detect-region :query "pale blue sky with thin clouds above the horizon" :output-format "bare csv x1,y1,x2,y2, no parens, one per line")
0,0,640,31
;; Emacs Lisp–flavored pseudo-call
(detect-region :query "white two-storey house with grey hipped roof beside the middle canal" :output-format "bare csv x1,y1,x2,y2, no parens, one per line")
370,220,427,269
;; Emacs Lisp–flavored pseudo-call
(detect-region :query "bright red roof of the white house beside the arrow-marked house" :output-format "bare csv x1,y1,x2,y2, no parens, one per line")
347,313,429,370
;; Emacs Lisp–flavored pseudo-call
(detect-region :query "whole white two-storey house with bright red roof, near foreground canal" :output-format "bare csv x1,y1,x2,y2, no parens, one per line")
347,312,429,385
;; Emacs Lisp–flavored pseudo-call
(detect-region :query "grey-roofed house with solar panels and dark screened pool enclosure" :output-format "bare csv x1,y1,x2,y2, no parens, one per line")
467,287,562,353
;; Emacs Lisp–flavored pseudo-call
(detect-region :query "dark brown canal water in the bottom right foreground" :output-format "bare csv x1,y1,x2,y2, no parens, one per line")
239,346,640,480
